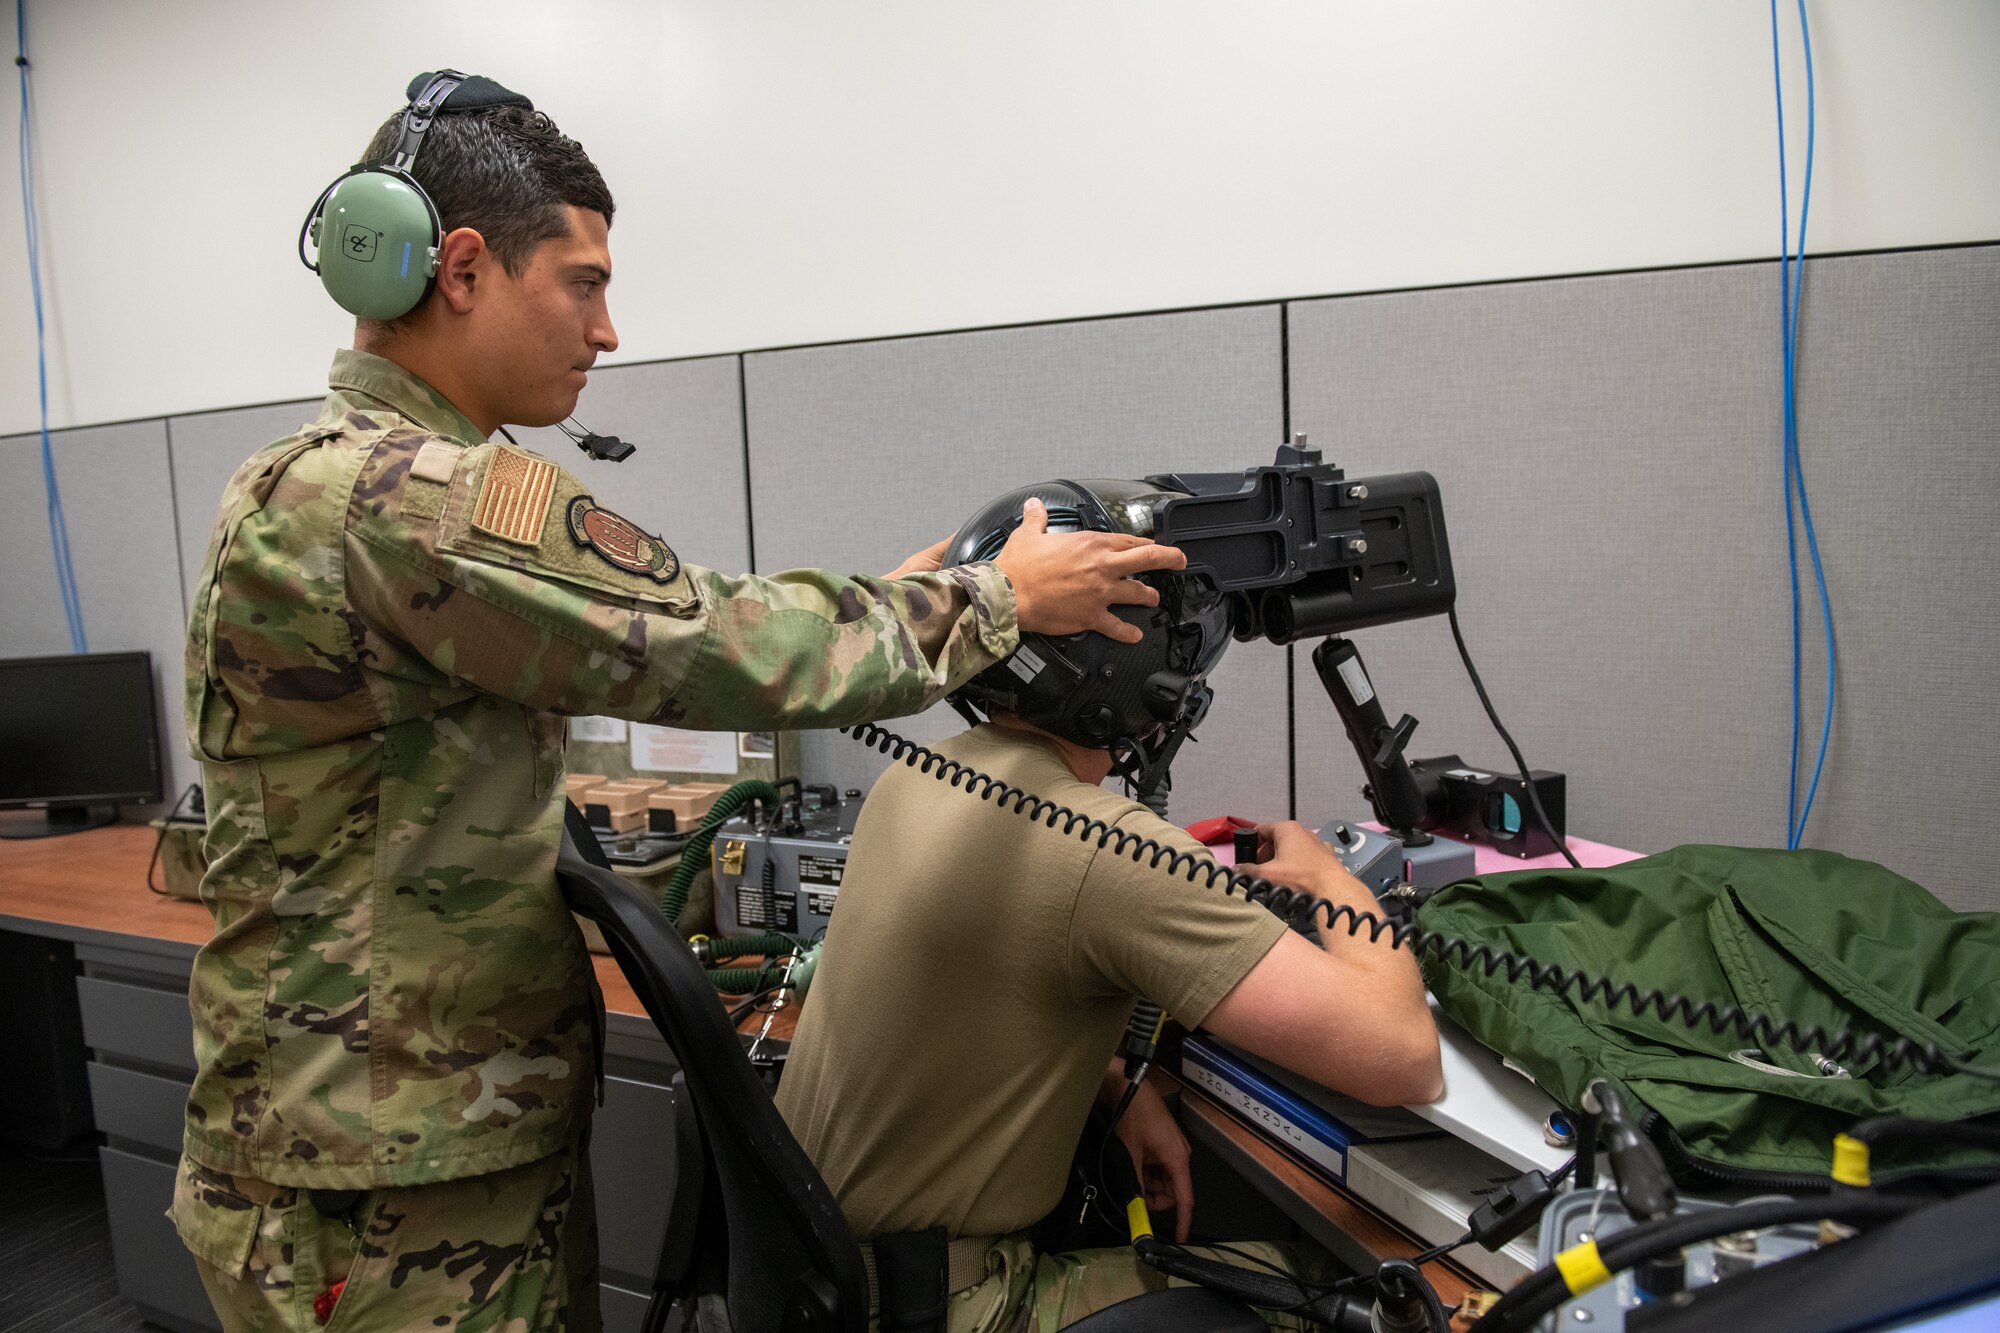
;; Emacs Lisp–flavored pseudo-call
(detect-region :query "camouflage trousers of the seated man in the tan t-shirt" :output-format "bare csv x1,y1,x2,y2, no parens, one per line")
916,1233,1336,1333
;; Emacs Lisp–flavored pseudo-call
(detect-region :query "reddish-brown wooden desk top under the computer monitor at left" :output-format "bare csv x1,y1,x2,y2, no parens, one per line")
0,825,798,1020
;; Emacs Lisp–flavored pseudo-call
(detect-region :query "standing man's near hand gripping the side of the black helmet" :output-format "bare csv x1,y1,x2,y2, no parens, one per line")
994,500,1188,642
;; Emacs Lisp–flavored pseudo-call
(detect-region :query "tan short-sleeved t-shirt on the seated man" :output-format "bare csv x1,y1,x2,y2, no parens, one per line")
778,727,1284,1239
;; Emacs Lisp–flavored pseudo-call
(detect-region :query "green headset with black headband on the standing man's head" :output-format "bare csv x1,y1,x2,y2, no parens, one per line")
298,70,534,320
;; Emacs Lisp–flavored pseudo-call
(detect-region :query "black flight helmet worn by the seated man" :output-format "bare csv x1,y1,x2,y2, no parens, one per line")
944,480,1232,797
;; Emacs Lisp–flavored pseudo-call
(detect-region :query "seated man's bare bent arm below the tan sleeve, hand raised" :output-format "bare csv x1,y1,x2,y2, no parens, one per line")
1202,823,1444,1107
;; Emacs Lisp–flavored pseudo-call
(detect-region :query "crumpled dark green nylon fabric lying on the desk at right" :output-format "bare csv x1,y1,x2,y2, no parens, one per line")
1418,847,2000,1185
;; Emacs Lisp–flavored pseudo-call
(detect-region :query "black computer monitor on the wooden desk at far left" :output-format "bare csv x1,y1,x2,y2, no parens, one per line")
0,652,162,839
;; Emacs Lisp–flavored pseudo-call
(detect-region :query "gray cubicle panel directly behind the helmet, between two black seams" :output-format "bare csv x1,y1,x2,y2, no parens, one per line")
744,306,1290,819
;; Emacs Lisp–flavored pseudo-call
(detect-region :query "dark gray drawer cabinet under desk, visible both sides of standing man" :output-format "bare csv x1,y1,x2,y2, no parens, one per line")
15,931,678,1333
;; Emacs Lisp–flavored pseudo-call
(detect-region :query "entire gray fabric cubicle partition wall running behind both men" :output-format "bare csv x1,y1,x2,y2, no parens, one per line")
0,244,2000,896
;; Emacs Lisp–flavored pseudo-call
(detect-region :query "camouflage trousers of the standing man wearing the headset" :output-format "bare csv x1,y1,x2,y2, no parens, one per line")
172,1149,600,1333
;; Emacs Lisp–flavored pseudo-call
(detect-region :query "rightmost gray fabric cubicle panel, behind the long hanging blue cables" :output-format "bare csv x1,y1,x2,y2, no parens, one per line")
1290,246,2000,909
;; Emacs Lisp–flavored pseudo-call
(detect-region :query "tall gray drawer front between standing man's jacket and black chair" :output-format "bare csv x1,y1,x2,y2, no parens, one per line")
590,1079,674,1291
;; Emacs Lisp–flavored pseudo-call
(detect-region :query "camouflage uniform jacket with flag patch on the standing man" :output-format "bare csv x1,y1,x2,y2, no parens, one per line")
186,350,1016,1189
